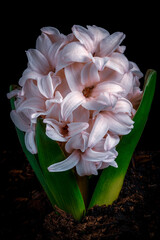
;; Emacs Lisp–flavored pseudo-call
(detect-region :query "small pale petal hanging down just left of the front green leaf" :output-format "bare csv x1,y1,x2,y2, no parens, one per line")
24,130,37,154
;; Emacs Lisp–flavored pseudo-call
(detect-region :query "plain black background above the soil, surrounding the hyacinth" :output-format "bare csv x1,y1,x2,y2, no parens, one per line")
0,4,160,154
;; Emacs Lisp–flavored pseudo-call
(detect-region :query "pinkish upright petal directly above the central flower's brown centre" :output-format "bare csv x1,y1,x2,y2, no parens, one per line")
81,62,100,87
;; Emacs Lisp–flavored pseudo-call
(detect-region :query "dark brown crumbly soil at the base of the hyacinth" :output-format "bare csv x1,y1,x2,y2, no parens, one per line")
0,147,160,240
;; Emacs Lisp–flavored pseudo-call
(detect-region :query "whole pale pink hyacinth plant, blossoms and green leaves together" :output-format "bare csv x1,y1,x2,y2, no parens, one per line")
7,25,156,220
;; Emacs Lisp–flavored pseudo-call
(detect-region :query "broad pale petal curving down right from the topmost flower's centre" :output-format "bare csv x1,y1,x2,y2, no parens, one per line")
105,52,129,74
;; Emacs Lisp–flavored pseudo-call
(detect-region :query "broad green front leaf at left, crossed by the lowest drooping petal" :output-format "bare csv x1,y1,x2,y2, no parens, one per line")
36,119,85,220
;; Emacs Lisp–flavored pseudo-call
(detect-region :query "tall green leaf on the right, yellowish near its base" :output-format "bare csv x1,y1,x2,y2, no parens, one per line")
89,70,156,208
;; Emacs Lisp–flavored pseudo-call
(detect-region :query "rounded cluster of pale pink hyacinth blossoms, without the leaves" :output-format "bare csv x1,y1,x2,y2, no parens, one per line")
8,25,143,176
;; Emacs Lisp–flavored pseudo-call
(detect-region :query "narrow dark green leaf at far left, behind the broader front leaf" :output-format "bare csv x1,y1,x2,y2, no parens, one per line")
10,86,56,205
